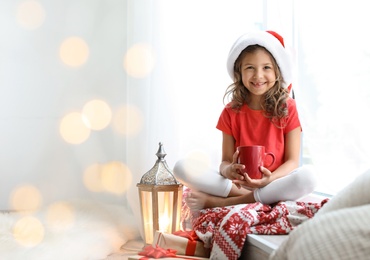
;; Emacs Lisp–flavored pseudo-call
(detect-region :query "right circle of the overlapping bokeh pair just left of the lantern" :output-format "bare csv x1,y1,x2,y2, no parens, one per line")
101,161,132,194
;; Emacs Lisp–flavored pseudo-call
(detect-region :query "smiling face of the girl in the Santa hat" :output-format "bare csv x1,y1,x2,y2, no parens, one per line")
241,49,276,99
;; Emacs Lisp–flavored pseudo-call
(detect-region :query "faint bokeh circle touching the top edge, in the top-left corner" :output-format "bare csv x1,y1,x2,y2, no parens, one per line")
16,0,45,30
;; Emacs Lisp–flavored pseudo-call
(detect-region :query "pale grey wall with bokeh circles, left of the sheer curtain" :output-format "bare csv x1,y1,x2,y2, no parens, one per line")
0,0,131,210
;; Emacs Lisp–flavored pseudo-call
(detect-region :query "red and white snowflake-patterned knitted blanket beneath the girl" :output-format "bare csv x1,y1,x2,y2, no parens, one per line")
183,192,328,260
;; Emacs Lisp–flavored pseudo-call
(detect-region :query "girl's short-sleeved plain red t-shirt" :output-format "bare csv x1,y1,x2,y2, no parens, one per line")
216,98,301,171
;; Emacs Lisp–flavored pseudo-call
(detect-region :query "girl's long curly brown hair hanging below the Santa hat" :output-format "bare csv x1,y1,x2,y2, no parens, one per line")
224,44,289,127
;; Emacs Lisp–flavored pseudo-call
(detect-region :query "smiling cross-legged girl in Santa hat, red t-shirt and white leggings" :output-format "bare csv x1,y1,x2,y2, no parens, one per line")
174,31,315,210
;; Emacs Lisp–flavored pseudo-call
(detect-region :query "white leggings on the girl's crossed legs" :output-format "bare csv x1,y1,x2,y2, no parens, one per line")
173,159,316,204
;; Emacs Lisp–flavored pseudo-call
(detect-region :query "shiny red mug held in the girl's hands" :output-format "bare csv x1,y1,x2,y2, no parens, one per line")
238,145,275,179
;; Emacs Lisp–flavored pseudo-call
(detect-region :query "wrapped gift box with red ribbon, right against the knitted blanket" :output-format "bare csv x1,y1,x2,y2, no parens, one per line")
153,230,210,258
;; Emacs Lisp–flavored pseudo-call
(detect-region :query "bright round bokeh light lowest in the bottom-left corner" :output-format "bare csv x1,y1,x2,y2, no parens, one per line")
13,216,45,247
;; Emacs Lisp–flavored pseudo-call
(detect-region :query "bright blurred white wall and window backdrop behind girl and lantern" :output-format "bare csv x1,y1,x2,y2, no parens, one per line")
0,0,370,228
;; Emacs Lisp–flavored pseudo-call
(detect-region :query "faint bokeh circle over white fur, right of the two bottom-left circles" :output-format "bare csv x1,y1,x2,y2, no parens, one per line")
46,202,75,231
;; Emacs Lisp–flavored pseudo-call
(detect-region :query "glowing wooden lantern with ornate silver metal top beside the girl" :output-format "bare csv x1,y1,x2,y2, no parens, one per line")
136,143,183,245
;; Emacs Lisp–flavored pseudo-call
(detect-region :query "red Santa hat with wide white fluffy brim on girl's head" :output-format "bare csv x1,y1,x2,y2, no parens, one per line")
227,31,293,88
